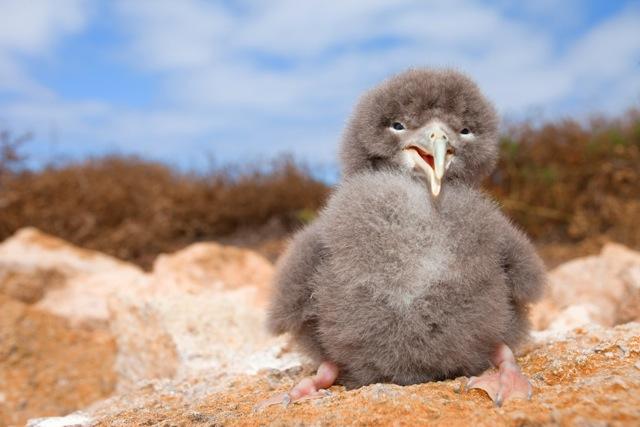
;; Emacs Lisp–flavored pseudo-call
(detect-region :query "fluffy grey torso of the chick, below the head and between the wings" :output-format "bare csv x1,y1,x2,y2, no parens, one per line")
272,171,535,387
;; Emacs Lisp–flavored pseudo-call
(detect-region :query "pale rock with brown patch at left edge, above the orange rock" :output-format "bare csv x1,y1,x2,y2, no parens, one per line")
0,228,149,328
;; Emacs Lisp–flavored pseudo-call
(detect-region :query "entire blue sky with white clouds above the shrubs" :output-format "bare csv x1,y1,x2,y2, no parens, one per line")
0,0,640,174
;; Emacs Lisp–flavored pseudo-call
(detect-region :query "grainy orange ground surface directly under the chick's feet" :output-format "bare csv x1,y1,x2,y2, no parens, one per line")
70,323,640,427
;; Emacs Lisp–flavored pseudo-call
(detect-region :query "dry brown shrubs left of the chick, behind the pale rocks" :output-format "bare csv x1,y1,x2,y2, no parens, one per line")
0,157,329,267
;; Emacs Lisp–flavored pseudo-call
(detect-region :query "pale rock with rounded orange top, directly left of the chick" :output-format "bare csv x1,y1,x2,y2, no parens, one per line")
103,239,288,390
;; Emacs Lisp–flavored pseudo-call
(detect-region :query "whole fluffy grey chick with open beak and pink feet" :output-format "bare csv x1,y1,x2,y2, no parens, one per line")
266,69,544,410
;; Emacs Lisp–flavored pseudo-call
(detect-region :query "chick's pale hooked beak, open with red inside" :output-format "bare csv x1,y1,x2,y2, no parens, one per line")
405,125,454,197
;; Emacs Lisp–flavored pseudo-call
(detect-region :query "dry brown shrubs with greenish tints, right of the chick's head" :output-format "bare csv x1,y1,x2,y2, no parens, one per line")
487,110,640,256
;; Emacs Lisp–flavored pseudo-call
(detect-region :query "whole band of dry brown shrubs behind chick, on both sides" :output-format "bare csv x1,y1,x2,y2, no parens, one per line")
0,111,640,266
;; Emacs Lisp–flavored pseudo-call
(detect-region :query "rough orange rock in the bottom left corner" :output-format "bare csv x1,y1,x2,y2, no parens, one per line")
0,295,116,425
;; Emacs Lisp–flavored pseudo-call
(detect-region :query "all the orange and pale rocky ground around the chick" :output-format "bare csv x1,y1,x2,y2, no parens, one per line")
0,229,640,426
